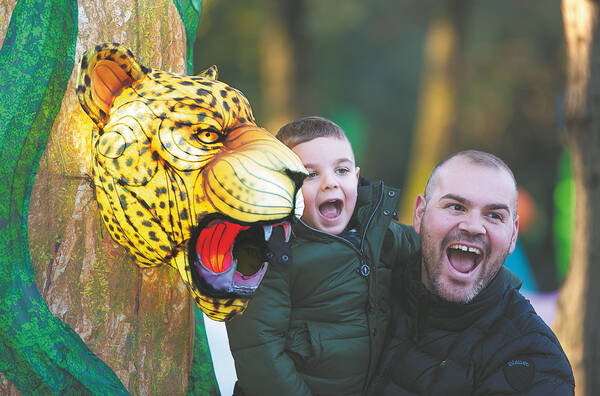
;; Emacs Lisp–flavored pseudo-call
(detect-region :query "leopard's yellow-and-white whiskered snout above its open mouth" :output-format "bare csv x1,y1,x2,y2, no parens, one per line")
203,126,306,222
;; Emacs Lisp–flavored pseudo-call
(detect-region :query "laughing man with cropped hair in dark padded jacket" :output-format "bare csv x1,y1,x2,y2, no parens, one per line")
369,151,574,395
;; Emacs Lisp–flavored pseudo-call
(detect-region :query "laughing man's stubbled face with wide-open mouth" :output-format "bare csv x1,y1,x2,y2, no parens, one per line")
413,157,519,303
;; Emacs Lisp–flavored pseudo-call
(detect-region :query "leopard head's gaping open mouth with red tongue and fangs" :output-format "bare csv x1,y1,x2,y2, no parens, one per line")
189,215,291,297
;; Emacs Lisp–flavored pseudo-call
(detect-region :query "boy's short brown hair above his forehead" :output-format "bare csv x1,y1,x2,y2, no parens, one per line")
276,116,349,148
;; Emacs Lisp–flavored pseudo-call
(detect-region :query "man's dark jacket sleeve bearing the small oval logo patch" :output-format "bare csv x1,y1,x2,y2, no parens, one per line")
475,319,575,396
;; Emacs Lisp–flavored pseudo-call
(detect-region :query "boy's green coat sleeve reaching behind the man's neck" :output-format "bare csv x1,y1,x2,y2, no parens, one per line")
381,221,421,268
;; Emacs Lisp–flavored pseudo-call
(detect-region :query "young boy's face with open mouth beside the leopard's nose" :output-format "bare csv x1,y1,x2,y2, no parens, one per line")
292,137,360,235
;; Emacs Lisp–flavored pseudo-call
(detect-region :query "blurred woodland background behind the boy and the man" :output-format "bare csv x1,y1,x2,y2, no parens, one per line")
194,0,566,291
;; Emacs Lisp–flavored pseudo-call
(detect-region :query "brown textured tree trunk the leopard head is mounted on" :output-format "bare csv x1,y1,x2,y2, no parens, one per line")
0,0,193,395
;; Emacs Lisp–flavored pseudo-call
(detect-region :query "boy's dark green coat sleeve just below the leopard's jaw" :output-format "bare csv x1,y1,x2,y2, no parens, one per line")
226,265,311,396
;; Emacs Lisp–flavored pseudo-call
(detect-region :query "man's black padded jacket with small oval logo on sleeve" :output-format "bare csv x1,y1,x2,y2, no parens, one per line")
369,257,575,396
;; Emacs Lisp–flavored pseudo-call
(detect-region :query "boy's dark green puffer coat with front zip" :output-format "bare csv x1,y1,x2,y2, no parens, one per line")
227,182,419,396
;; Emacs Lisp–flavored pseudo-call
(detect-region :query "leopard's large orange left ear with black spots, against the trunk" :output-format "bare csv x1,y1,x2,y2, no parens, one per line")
77,43,150,127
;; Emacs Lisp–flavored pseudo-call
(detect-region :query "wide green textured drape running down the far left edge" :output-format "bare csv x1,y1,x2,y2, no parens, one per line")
0,0,128,395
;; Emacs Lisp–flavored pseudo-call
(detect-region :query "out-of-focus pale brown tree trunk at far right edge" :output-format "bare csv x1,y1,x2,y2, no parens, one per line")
554,0,600,395
